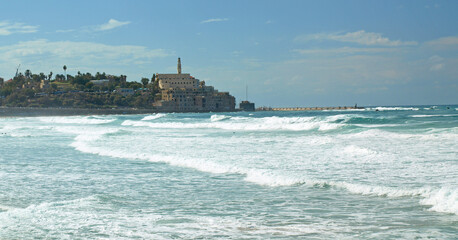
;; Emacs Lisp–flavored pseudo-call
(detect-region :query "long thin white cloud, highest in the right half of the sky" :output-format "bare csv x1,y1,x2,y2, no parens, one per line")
295,30,418,47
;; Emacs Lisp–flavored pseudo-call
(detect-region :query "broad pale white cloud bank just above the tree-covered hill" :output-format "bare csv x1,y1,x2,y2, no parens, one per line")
0,39,172,76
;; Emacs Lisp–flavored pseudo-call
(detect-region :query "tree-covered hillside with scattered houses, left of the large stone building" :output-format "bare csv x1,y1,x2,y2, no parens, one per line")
0,68,160,108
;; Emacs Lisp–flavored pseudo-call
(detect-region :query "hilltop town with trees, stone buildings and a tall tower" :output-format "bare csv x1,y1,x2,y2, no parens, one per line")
0,58,235,112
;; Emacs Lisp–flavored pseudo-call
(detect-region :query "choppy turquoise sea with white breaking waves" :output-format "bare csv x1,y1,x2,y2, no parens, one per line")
0,105,458,239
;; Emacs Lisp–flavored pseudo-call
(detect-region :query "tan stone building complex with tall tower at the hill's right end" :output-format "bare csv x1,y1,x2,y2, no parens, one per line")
154,58,235,112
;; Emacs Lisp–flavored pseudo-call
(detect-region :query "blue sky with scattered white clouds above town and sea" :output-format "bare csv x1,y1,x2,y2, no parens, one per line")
0,0,458,107
